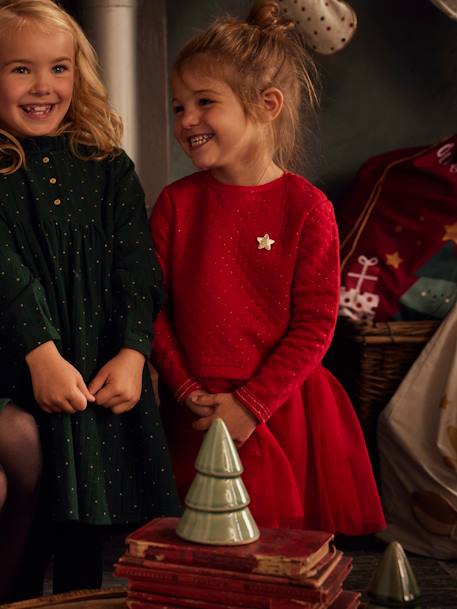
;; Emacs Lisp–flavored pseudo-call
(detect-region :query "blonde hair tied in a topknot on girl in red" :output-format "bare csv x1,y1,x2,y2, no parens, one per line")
173,0,318,169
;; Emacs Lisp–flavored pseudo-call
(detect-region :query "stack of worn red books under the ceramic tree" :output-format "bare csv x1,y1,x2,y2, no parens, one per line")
115,518,360,609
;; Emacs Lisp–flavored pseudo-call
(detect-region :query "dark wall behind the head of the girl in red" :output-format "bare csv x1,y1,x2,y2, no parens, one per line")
167,0,457,203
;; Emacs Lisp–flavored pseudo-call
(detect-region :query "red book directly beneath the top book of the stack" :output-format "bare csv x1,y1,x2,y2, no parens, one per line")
115,557,352,609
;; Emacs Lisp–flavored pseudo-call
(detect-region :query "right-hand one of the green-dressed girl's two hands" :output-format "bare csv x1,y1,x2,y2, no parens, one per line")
89,348,145,414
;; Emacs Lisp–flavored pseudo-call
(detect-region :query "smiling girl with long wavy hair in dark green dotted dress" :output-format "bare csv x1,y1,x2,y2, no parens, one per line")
0,0,178,595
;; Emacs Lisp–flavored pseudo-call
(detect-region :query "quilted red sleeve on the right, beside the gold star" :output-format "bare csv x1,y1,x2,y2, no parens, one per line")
235,199,339,421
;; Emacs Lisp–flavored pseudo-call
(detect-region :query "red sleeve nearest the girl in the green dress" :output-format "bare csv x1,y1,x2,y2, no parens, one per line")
150,191,201,401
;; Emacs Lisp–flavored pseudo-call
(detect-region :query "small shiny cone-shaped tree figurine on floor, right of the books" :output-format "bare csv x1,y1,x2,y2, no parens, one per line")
367,541,420,609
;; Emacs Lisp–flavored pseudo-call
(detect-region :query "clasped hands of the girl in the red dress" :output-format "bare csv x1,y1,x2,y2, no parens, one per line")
192,393,258,448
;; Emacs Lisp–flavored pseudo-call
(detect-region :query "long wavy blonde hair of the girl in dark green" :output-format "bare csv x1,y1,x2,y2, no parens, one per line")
0,0,122,174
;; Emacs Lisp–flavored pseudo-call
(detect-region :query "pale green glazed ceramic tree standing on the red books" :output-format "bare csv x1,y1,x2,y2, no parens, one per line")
176,419,260,545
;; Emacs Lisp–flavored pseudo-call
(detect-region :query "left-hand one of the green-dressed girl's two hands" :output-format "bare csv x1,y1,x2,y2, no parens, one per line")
25,341,95,414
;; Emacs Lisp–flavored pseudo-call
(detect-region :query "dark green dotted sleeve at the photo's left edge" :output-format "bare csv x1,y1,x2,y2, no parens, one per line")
0,218,60,358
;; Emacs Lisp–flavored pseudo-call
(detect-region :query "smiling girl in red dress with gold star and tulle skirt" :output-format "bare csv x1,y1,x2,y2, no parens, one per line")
151,1,384,535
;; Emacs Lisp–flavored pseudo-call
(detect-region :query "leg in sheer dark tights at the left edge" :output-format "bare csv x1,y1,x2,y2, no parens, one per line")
0,404,42,602
